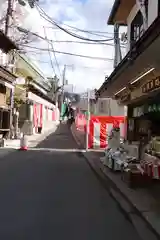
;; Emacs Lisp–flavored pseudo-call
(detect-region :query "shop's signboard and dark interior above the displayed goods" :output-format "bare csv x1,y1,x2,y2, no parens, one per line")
126,76,160,143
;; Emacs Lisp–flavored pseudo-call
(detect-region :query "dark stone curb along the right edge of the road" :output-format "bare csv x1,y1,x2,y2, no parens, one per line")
71,126,160,240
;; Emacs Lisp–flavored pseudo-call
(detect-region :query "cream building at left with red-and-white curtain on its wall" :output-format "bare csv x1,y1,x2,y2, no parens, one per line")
15,54,58,135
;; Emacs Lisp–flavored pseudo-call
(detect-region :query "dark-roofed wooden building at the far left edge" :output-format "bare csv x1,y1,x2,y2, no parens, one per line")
0,31,17,136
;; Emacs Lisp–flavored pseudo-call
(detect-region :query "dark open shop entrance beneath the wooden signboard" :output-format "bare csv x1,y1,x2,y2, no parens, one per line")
128,94,160,142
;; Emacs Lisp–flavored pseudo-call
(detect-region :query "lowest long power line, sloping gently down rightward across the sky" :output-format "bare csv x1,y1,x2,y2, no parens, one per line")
21,44,113,61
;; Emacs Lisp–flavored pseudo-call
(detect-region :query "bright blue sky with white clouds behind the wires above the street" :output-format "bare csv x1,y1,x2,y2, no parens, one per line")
2,0,127,92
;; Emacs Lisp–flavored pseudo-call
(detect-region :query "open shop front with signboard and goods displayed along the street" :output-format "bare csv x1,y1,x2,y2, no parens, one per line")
99,74,160,187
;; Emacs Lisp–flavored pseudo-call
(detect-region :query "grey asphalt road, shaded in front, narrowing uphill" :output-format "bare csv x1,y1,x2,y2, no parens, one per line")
0,126,140,240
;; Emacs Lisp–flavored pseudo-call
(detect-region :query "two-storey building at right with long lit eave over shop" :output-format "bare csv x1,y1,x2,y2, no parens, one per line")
97,0,160,142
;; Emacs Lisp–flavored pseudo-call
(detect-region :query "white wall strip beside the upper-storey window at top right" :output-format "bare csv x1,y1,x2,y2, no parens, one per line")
148,0,158,27
